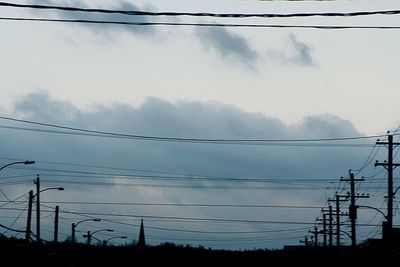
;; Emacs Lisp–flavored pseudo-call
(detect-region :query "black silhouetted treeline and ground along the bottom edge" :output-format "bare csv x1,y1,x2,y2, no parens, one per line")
0,238,400,267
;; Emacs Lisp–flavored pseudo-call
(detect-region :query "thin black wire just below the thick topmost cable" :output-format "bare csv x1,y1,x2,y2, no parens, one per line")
0,17,400,30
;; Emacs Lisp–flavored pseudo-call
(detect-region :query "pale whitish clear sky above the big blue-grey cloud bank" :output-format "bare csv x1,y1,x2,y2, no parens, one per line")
0,1,400,134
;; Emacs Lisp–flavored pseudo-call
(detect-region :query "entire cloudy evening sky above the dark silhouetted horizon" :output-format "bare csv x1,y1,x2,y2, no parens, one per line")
0,0,400,249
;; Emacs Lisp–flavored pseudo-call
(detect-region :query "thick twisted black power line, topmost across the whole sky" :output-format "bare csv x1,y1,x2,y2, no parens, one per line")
0,2,400,18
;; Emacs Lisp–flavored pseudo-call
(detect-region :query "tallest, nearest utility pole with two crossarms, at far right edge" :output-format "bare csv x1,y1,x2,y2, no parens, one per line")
375,134,400,238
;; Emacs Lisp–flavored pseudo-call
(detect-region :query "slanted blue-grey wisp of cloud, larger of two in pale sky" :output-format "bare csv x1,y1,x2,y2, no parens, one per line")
196,27,259,68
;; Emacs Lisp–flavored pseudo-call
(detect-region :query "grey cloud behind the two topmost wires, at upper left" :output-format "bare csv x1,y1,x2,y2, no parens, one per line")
30,0,156,38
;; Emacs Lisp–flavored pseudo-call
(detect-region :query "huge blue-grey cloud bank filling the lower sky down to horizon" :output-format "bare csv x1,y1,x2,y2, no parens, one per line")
0,92,378,249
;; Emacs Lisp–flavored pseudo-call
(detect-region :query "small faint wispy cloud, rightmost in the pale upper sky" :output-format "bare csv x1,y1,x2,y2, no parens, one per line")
266,34,315,66
